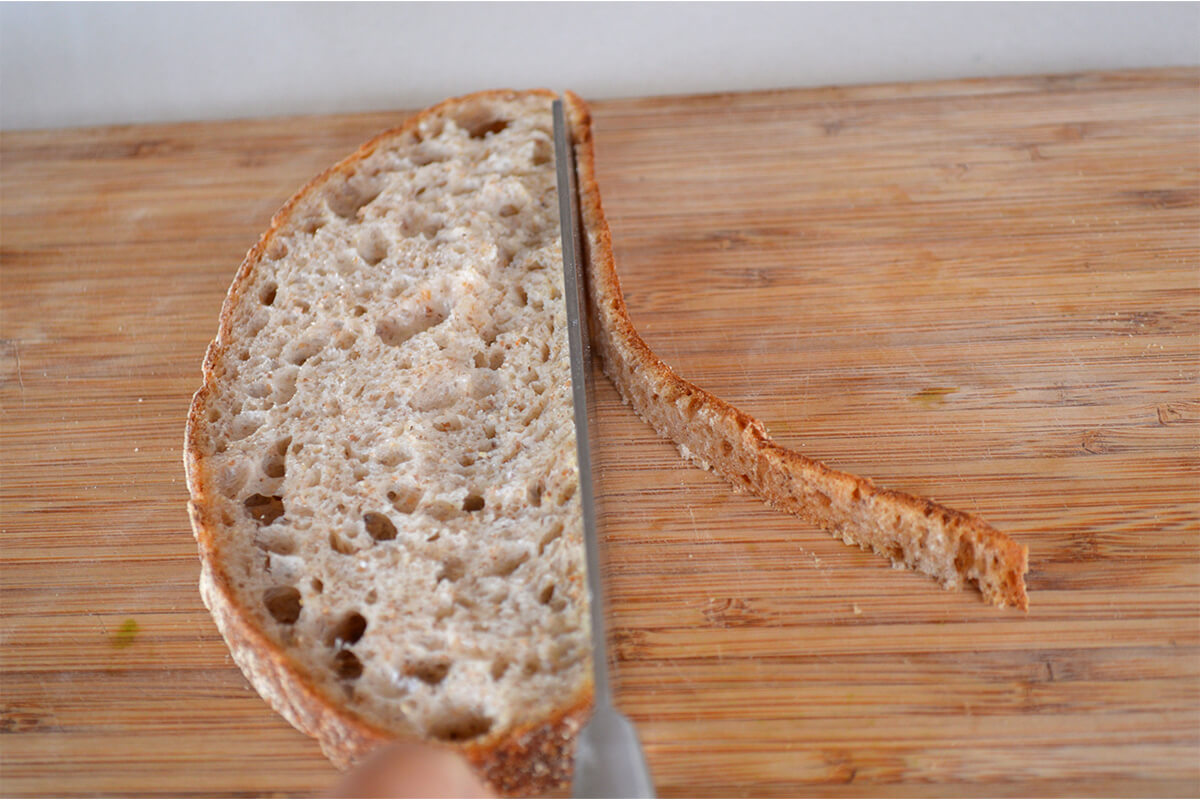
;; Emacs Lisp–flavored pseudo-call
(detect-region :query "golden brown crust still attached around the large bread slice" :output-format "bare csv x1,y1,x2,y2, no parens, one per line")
184,90,592,794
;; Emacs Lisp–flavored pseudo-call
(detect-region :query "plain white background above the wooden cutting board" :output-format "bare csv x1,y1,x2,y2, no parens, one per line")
0,2,1200,130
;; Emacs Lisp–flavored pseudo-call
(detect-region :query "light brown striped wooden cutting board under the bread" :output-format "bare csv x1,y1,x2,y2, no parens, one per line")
0,70,1200,795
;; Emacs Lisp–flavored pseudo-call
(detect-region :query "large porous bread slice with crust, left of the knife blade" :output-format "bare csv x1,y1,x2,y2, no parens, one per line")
187,92,592,792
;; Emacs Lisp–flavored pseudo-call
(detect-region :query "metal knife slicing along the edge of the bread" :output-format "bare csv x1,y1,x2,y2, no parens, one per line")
553,100,654,798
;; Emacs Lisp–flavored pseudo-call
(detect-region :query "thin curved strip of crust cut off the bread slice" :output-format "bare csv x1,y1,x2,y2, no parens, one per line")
566,92,1028,609
